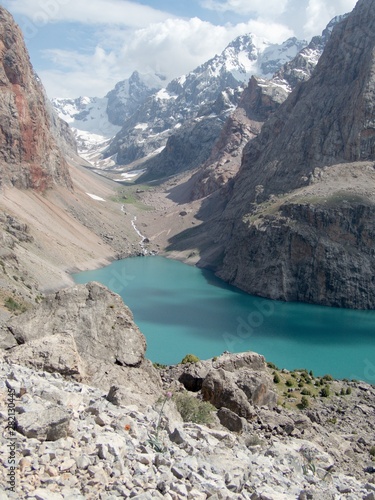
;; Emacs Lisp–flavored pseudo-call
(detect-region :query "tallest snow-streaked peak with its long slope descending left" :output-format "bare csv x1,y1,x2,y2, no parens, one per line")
105,34,307,165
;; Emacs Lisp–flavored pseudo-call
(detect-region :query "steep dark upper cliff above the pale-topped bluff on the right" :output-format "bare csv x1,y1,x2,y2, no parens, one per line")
229,0,375,204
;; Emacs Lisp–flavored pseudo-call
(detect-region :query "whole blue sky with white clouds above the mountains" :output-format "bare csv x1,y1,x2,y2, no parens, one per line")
2,0,356,97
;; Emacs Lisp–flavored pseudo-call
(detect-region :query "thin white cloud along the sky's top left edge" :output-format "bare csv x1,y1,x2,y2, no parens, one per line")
6,0,171,27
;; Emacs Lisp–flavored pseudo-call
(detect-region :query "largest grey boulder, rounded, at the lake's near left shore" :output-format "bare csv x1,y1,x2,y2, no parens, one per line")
8,282,146,366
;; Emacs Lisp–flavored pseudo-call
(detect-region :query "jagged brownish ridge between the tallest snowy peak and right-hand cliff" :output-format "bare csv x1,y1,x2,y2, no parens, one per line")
190,15,347,200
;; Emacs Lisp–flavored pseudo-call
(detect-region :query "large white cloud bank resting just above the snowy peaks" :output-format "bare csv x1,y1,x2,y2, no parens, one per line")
39,18,293,97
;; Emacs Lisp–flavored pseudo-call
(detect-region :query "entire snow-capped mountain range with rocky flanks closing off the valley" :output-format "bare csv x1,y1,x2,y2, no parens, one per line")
54,18,340,175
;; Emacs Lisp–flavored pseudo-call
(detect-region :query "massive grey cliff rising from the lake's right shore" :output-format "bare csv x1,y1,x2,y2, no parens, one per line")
200,0,375,308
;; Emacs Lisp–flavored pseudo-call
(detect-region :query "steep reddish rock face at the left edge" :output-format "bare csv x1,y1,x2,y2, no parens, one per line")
0,7,72,191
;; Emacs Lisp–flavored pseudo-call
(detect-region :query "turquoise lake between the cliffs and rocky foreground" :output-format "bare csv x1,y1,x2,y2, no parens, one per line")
73,256,375,384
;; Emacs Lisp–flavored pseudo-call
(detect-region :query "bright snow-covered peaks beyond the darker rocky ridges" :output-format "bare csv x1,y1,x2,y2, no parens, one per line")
53,34,306,172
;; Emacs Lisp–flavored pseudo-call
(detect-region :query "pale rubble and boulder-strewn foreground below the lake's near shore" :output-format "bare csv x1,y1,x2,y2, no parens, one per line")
0,283,375,500
